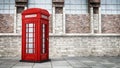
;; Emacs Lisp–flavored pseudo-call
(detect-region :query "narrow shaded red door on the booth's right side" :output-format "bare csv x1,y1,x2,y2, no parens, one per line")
41,20,49,60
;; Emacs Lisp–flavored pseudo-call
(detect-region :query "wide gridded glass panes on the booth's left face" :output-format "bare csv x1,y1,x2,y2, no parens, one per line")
26,23,35,54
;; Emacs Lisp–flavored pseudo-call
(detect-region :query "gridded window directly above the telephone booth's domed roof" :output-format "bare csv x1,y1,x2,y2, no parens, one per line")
28,0,52,13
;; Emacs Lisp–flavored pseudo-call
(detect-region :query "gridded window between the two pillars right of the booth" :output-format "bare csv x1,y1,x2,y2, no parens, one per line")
65,0,88,14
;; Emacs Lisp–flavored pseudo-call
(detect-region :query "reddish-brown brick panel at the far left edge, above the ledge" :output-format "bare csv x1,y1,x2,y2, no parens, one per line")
0,14,14,33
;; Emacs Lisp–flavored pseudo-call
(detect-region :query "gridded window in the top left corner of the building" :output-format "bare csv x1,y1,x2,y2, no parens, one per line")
0,0,15,14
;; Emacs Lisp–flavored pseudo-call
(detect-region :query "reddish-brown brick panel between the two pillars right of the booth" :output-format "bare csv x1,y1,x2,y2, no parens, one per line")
66,14,90,33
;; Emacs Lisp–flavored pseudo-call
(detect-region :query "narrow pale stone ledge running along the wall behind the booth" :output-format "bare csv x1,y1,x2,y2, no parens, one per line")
0,33,120,37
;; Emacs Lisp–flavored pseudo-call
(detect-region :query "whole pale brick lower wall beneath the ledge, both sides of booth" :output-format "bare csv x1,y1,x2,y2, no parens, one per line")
0,36,120,58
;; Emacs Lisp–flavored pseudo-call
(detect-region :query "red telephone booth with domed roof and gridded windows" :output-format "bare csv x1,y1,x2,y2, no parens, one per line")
21,8,50,62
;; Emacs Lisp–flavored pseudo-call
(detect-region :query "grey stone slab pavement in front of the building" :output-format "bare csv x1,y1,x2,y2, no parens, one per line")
0,56,120,68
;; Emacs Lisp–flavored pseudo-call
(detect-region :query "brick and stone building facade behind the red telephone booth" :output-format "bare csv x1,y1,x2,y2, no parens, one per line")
0,0,120,57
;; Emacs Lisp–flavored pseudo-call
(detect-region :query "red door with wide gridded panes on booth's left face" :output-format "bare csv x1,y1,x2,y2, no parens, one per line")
22,20,37,61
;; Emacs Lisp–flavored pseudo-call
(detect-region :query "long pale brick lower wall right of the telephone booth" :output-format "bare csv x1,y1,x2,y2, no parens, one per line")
50,36,120,57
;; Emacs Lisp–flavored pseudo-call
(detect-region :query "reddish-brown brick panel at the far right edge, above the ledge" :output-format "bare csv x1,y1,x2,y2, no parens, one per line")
101,15,120,33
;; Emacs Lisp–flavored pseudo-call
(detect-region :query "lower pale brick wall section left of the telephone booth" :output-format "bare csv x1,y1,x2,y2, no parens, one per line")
0,35,21,57
